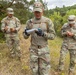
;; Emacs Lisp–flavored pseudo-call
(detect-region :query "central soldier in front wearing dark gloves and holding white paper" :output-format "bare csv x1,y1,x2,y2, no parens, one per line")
23,2,55,75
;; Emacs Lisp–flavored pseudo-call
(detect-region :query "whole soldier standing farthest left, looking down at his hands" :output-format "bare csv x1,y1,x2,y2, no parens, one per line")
1,8,21,58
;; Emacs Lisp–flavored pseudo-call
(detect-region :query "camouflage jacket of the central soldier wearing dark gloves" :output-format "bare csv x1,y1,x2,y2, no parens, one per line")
24,16,55,47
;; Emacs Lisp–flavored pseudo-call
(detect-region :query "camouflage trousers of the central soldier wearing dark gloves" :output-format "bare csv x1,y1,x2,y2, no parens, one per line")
30,47,50,75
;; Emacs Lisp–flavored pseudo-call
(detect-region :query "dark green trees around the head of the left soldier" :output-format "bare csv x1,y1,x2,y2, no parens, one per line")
0,1,33,42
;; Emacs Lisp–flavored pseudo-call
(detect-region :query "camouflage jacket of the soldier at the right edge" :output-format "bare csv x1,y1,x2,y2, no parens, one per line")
61,23,76,49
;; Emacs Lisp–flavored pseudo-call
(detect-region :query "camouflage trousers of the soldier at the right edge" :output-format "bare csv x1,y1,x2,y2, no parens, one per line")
59,46,76,73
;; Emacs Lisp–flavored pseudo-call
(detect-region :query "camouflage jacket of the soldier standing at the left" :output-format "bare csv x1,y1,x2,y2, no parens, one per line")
1,16,21,36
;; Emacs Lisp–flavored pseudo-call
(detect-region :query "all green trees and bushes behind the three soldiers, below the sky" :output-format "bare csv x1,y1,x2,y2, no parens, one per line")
0,0,76,40
